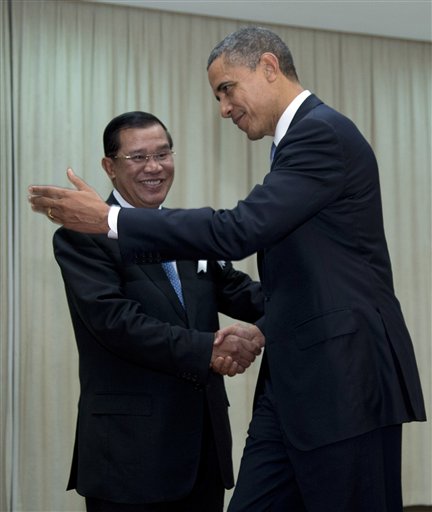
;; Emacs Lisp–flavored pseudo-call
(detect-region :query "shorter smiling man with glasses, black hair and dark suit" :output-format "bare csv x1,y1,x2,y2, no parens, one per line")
54,112,263,512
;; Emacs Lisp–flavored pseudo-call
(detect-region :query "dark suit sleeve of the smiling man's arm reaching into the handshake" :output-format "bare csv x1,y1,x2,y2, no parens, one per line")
53,228,214,382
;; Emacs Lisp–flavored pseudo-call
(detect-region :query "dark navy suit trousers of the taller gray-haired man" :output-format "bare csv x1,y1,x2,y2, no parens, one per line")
228,381,403,512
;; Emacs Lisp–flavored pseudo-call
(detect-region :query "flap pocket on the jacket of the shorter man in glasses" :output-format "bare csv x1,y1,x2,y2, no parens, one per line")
91,394,152,416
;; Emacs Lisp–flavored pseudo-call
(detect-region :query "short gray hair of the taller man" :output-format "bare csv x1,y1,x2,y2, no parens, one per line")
207,27,298,81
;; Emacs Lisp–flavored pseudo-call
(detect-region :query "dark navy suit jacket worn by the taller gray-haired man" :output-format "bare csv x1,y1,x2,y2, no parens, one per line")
118,95,425,450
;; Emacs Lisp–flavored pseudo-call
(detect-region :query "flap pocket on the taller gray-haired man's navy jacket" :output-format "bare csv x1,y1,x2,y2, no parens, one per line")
294,309,357,350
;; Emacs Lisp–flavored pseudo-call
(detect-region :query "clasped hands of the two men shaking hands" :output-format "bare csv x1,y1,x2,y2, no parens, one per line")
210,324,265,377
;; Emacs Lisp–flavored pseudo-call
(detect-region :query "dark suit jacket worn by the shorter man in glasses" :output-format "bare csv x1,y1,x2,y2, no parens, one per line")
54,193,263,503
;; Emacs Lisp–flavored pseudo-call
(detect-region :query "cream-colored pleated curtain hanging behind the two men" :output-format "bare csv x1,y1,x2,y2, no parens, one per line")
0,0,432,512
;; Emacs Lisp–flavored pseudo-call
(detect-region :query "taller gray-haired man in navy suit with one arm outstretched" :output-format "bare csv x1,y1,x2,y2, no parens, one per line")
30,27,425,512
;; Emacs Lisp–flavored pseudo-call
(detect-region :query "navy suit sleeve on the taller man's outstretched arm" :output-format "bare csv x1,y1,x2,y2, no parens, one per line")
118,114,344,263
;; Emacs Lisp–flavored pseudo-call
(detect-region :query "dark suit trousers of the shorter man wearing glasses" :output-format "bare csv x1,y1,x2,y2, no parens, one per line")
86,409,225,512
